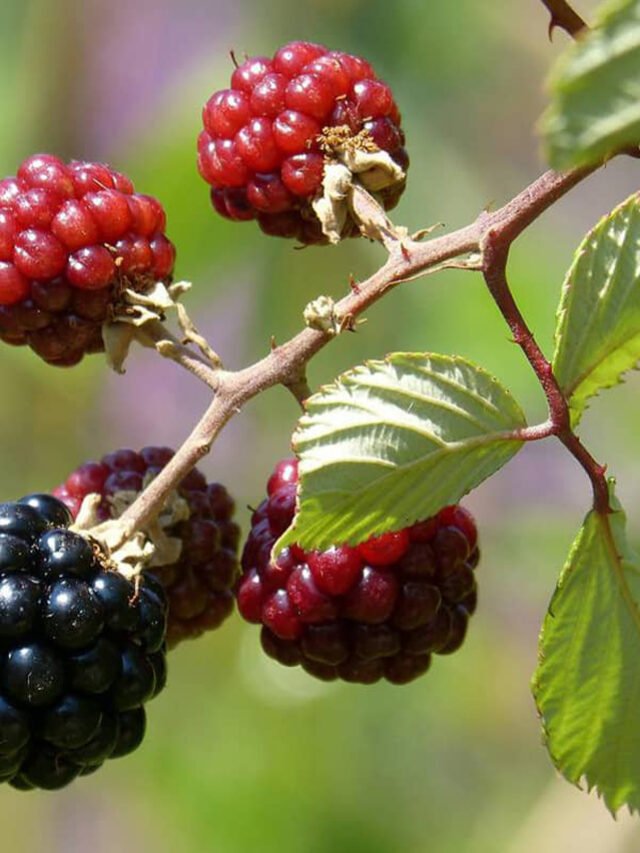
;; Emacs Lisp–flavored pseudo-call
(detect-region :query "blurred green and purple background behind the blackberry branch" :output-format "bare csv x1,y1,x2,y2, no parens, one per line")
0,0,640,853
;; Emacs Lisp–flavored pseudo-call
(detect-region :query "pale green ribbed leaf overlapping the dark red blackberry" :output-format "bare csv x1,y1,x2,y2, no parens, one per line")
274,353,525,552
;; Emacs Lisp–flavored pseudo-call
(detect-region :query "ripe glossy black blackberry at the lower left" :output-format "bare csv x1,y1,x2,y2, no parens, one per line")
0,495,167,790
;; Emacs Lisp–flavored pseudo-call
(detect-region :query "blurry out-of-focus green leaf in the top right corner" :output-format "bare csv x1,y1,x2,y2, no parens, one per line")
541,0,640,169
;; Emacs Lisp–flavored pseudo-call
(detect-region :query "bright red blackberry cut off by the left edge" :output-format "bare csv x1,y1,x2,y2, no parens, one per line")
0,154,175,367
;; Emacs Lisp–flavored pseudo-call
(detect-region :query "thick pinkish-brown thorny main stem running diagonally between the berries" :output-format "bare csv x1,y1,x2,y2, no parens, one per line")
115,165,598,541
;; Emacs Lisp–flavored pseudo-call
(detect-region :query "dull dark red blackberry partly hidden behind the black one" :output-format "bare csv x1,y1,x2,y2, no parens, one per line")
53,447,240,648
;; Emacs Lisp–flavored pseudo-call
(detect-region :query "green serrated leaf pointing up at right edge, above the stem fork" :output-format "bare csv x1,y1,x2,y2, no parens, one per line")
553,195,640,426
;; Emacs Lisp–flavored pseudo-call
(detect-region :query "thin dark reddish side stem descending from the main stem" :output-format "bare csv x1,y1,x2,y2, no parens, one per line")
482,231,611,514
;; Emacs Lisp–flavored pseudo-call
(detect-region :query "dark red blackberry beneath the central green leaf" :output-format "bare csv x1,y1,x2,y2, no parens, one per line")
236,459,480,684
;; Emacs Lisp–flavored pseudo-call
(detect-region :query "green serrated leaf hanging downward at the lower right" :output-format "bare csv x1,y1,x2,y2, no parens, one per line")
533,482,640,812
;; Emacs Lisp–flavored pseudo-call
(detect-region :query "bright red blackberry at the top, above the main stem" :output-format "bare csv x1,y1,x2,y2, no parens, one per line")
198,41,409,243
